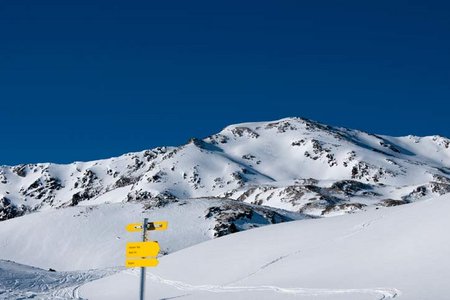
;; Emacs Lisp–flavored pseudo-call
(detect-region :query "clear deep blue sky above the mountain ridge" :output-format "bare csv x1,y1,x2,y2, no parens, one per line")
0,0,450,165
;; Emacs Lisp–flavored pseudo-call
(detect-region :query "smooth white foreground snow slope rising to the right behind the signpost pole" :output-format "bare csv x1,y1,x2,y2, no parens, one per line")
79,196,450,300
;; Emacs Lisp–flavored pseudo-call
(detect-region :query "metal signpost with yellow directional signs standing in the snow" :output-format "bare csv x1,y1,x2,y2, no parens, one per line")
125,218,168,300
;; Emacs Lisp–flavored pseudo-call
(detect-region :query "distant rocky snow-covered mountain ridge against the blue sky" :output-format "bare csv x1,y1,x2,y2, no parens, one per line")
0,118,450,220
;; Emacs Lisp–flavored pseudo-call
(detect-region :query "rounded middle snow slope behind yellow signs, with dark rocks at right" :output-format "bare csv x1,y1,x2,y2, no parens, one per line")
0,199,306,271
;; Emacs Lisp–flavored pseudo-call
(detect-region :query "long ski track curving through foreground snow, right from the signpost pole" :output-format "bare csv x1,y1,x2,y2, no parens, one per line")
127,271,400,300
